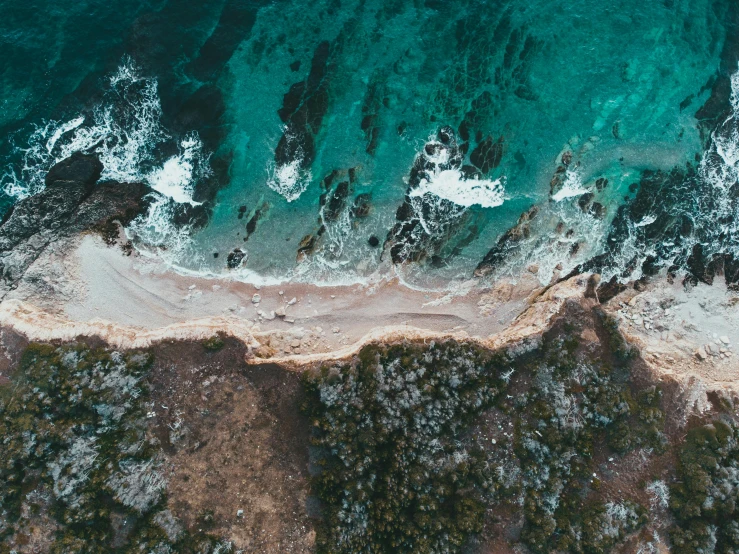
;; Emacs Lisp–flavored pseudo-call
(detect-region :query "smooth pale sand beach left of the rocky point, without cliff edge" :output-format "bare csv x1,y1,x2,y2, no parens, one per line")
3,234,542,354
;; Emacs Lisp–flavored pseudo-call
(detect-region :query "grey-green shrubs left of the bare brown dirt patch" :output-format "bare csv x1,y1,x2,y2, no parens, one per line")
0,344,231,554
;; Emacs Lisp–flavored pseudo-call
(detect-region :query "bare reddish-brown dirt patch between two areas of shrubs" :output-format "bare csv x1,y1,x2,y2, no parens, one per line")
150,340,314,553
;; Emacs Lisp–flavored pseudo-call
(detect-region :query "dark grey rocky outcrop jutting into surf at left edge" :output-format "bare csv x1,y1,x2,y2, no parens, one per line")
0,152,149,295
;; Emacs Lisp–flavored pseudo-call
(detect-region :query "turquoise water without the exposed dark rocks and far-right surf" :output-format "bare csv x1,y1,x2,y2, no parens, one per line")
0,0,731,286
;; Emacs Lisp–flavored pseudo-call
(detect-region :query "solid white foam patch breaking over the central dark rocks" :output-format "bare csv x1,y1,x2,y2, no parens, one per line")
410,169,505,208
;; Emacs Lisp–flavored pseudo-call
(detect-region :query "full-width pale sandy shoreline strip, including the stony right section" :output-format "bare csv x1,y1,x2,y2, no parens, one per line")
0,234,739,390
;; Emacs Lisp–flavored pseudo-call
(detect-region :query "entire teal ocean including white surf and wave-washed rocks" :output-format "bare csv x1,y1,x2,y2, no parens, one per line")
0,0,739,289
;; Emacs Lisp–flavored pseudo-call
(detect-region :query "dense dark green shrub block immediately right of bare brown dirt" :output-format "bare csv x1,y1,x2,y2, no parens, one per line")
304,342,505,553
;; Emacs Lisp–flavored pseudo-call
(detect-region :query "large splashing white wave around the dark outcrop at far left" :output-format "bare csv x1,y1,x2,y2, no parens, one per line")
0,58,210,257
